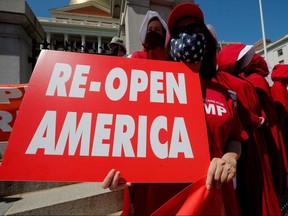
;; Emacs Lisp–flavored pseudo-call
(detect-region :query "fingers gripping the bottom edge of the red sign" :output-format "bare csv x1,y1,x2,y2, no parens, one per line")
102,169,131,191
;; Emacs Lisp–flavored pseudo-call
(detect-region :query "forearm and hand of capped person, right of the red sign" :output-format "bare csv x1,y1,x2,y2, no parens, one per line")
206,140,241,190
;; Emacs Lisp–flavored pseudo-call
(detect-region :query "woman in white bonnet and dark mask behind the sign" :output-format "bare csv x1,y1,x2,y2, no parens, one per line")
131,10,169,60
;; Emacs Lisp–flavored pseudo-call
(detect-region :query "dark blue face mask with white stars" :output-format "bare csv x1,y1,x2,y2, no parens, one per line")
170,33,206,63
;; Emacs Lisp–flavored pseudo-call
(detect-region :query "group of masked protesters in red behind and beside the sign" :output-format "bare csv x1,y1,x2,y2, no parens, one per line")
102,2,288,215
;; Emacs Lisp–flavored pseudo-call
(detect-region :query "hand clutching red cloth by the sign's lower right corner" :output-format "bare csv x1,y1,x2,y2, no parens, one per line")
206,157,237,190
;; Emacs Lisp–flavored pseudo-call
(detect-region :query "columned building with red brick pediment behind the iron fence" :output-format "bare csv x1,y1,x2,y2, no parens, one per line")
38,0,119,53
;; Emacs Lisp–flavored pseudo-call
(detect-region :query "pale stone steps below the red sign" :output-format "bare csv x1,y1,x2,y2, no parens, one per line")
0,142,123,216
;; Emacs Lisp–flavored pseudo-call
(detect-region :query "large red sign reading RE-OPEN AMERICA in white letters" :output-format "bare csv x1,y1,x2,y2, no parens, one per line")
0,51,210,182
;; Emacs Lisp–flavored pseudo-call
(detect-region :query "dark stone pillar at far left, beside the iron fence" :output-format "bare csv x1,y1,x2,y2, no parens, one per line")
0,0,45,84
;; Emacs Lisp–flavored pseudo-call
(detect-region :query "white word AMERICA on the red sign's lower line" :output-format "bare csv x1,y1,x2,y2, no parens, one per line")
26,110,194,159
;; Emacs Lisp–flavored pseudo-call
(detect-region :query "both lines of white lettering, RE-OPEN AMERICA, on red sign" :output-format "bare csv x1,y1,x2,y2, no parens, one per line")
26,63,194,159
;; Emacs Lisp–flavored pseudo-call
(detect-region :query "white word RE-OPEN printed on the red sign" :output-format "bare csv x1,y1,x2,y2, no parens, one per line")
46,63,187,104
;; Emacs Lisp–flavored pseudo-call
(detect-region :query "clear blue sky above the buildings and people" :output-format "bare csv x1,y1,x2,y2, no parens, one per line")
26,0,288,44
